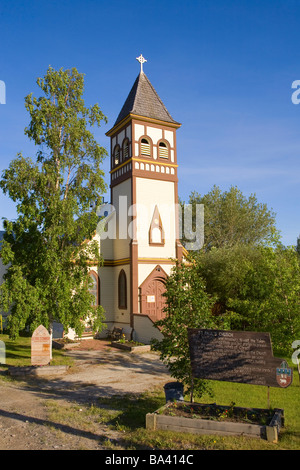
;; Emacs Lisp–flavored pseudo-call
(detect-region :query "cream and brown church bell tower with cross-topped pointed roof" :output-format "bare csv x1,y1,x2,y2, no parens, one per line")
106,55,183,342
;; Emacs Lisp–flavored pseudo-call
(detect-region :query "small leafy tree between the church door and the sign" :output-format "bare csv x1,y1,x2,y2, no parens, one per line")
153,263,218,401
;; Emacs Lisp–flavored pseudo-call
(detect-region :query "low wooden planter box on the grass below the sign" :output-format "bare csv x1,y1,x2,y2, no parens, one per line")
146,403,284,442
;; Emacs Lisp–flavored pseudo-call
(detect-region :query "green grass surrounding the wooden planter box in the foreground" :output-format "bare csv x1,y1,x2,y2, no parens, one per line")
92,370,300,450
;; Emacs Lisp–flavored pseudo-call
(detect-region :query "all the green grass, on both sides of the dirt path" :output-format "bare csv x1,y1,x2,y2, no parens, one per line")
0,335,300,450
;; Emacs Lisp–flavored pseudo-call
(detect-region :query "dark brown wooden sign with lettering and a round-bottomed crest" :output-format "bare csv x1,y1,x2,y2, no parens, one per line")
188,328,292,388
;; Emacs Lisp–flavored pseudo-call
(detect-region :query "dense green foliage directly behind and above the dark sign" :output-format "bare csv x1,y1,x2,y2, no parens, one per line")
195,245,300,354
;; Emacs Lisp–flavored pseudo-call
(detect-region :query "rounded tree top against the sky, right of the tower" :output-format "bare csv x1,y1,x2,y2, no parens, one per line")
182,186,279,251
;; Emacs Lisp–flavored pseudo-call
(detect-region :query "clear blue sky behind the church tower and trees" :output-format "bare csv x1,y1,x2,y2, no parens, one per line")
0,0,300,245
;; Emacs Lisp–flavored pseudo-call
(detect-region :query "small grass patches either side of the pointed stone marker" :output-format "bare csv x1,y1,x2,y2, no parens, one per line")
0,334,72,367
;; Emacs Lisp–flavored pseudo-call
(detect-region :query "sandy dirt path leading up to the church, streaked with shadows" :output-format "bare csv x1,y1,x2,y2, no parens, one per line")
0,340,170,450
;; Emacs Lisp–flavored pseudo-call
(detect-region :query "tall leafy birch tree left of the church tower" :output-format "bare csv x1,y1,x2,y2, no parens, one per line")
0,67,107,337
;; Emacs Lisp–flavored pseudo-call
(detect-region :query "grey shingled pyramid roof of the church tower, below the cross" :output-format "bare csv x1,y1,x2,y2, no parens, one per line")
114,72,178,126
